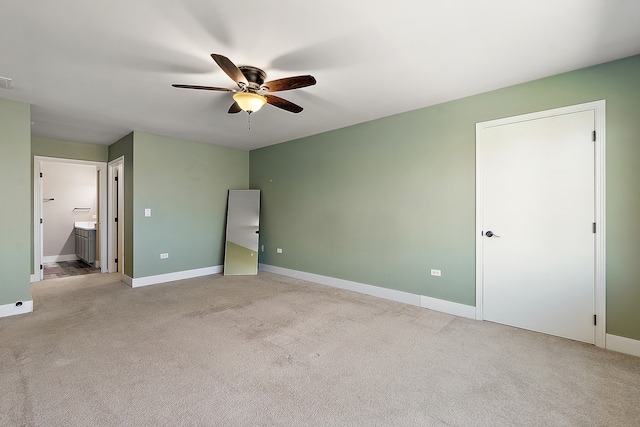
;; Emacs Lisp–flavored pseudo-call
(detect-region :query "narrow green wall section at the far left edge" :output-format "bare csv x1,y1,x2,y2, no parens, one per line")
0,98,33,305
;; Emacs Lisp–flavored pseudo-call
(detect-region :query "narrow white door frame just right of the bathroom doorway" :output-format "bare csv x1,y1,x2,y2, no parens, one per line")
107,156,125,273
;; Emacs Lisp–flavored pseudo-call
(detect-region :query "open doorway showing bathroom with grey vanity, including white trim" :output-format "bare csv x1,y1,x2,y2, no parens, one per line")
32,156,108,282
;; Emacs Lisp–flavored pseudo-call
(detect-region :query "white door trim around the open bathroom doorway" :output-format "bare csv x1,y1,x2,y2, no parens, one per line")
31,156,107,282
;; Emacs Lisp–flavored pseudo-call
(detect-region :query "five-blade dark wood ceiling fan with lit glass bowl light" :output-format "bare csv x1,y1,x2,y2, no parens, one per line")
171,53,316,114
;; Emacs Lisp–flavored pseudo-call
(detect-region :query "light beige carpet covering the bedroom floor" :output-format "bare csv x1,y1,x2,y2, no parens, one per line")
0,272,640,426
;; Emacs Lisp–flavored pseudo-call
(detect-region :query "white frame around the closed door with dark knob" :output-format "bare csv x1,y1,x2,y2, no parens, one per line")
476,100,606,348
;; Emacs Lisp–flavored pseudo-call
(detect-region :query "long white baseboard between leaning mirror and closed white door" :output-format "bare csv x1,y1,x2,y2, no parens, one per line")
259,264,476,319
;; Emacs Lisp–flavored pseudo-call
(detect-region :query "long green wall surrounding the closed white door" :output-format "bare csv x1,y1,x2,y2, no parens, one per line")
250,56,640,339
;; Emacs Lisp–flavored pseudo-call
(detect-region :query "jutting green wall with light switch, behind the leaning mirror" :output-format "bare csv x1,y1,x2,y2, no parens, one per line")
109,131,249,279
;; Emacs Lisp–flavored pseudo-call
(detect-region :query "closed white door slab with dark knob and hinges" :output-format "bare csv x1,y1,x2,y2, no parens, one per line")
477,110,595,343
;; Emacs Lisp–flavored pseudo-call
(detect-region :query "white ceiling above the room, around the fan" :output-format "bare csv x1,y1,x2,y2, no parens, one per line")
0,0,640,149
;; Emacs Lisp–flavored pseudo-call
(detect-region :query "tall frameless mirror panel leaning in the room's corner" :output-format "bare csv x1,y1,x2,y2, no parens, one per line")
224,190,260,276
